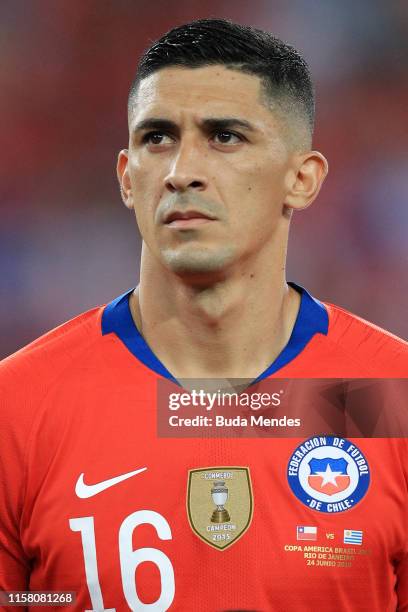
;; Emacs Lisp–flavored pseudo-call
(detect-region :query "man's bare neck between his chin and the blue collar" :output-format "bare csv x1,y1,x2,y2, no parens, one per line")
130,243,300,380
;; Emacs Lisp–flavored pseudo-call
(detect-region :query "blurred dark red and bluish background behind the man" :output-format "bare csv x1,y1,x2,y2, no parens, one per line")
0,0,408,356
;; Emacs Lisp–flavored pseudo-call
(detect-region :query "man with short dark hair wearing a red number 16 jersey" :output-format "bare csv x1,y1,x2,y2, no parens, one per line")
0,19,408,612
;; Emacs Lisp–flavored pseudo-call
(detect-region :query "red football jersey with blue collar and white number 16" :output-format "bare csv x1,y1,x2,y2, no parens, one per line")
0,288,408,612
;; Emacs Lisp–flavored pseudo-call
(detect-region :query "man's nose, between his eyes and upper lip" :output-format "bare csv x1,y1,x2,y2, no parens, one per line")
164,143,208,193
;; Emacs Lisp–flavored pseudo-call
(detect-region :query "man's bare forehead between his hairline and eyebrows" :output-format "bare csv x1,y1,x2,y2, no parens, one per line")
131,66,271,123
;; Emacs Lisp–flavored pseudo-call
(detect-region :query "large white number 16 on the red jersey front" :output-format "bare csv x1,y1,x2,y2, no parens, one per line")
69,510,175,612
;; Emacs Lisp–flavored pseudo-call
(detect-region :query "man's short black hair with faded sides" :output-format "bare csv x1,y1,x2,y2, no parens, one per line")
129,19,315,141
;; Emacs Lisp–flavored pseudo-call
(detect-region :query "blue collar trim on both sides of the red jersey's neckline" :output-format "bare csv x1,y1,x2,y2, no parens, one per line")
102,283,329,383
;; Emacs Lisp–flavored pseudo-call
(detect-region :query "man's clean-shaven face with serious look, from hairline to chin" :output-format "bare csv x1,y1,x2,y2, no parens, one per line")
118,66,302,275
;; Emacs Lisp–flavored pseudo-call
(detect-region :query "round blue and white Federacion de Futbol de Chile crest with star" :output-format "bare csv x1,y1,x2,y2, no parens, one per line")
287,436,370,513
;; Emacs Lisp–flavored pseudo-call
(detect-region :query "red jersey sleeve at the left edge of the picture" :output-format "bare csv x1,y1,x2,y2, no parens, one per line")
0,362,31,592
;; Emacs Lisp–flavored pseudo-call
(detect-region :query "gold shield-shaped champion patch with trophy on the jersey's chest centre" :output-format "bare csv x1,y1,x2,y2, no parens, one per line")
187,467,254,550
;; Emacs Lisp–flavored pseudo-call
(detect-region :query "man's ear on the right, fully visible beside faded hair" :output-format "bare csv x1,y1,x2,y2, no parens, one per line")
284,151,329,210
